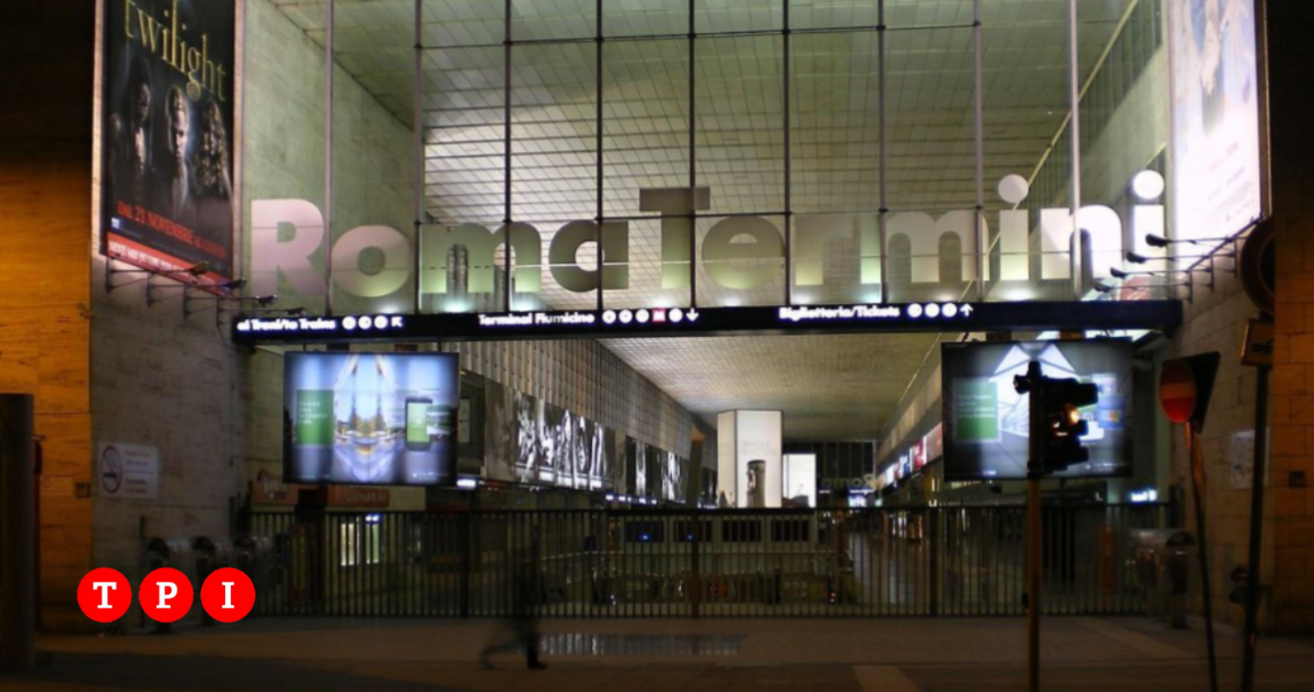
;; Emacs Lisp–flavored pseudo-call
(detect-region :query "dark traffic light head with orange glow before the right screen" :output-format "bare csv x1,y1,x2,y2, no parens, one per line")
1013,361,1100,475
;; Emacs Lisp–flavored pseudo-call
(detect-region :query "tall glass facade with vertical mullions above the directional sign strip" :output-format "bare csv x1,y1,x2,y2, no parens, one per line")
248,0,1168,313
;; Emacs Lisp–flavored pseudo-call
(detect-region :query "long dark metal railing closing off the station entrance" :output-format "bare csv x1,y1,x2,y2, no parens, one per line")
251,504,1172,617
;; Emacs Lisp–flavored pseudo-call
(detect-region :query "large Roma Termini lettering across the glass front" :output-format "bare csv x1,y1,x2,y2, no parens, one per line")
250,172,1166,313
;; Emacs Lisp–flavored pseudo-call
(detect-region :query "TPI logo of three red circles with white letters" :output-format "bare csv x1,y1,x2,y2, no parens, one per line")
78,567,255,624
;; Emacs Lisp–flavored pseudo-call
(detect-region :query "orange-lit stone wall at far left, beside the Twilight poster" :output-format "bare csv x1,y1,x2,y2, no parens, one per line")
0,0,96,629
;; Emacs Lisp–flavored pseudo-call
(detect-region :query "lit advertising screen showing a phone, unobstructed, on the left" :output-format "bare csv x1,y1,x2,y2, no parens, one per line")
283,353,460,486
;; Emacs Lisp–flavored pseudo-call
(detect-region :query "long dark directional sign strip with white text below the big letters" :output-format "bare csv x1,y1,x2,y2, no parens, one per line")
233,301,1181,344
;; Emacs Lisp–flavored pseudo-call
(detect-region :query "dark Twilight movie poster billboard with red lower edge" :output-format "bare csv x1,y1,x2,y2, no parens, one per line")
101,0,235,282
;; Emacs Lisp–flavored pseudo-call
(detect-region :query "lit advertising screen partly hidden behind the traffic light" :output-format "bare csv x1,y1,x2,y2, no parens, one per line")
941,340,1133,481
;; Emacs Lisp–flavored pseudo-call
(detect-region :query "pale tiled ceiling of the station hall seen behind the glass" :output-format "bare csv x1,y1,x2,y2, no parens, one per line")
273,0,1137,439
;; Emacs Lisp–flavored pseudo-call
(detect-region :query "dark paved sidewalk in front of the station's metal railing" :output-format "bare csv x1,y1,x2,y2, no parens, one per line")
0,617,1314,692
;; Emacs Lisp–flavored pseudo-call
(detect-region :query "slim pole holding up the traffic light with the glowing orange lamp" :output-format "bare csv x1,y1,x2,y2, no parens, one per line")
1026,361,1045,692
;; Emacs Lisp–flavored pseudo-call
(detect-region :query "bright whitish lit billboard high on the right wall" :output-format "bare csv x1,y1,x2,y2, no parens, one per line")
1167,0,1261,256
